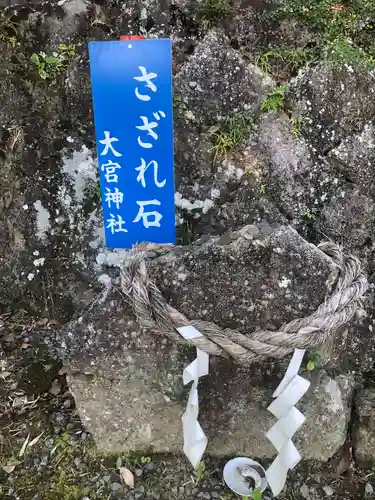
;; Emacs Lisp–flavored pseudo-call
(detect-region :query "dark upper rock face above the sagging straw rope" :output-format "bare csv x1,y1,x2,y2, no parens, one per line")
151,225,335,333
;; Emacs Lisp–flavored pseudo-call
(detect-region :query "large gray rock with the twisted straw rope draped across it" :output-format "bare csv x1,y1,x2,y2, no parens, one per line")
64,223,352,460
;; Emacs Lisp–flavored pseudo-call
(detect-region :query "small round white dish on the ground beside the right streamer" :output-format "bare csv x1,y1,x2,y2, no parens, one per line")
223,457,268,497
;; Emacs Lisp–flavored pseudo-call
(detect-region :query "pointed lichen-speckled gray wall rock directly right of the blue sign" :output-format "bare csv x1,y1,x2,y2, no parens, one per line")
174,30,277,239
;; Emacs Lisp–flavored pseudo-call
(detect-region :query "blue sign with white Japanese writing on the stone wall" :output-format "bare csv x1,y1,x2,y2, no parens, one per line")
89,40,176,248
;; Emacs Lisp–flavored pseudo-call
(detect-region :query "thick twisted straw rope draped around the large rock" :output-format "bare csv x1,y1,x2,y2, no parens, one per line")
121,243,368,365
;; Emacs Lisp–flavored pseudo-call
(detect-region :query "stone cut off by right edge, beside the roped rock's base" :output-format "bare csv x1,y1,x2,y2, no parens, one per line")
355,388,375,467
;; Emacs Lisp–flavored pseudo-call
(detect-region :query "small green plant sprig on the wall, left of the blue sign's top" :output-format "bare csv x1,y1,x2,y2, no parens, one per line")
30,43,76,84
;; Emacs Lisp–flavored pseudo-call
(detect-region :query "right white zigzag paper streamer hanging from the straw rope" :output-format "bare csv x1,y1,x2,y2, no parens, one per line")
266,349,310,496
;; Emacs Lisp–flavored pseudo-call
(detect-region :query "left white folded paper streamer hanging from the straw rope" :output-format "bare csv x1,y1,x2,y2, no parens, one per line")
177,326,209,469
